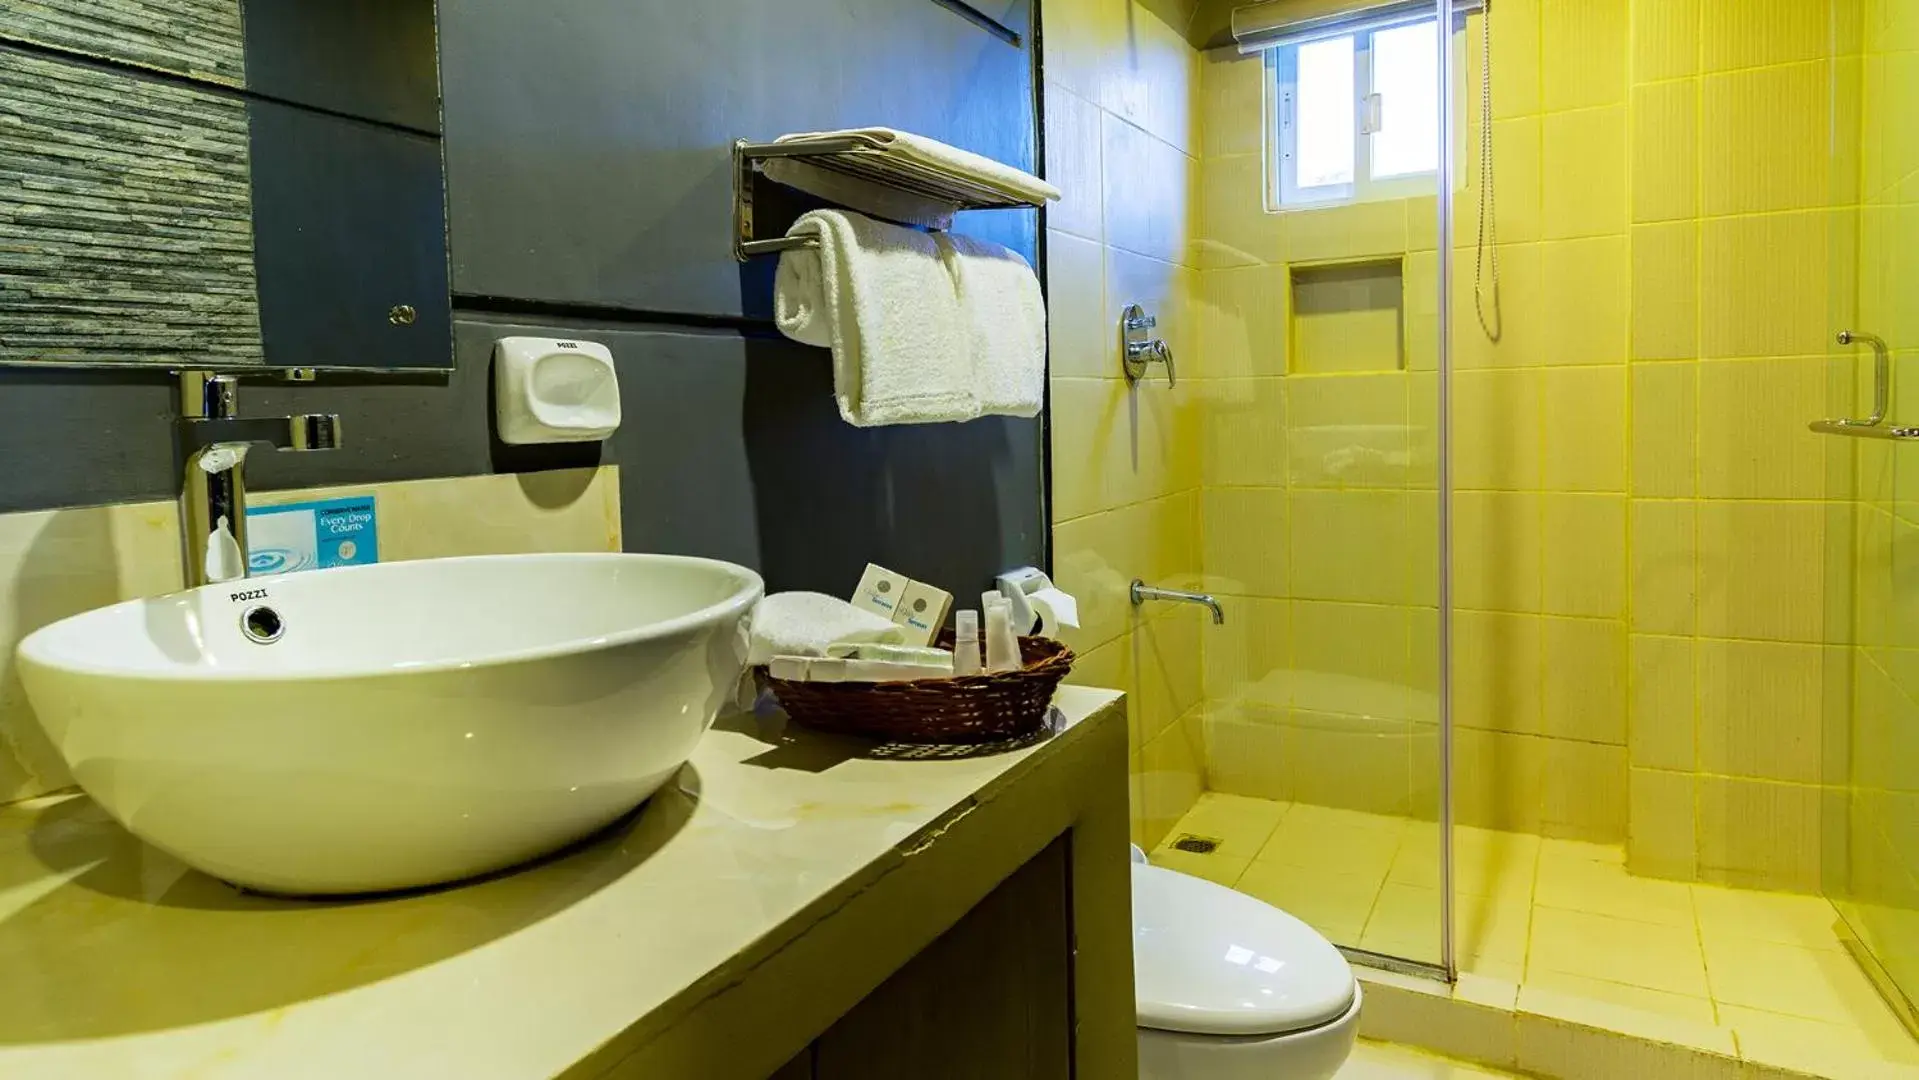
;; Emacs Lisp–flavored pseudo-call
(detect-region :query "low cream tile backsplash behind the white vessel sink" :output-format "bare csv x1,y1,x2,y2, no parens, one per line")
0,466,620,804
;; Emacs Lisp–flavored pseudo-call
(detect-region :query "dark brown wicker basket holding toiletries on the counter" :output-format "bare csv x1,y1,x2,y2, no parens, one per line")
766,635,1073,744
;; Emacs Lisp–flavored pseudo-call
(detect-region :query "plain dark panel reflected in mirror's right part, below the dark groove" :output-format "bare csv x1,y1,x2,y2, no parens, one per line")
248,102,453,368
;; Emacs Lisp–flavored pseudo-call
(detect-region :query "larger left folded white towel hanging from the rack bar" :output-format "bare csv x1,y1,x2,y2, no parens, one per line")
775,209,979,428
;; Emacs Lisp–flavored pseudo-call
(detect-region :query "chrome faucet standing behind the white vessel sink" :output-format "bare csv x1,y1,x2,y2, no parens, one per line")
178,372,340,589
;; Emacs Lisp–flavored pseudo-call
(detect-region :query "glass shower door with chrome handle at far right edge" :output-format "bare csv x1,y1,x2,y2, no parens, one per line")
1825,0,1919,1028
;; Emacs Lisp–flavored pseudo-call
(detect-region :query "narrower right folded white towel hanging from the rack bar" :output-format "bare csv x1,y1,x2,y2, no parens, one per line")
950,236,1046,416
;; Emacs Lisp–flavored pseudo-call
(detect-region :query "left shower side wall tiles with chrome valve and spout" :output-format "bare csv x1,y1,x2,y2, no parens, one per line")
1042,0,1205,848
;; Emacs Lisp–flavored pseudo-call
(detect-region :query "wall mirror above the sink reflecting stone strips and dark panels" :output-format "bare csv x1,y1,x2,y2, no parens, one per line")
0,0,453,372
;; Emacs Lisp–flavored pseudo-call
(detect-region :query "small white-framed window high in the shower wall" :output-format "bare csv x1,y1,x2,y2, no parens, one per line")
1267,19,1439,209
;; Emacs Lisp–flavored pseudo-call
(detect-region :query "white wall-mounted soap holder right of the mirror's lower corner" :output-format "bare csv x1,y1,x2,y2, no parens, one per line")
493,338,620,445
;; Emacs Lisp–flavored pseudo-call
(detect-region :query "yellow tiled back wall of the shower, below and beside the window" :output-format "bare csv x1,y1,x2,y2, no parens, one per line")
1188,0,1865,874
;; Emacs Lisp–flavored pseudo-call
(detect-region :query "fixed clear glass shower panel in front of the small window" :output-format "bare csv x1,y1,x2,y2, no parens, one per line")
1188,0,1462,973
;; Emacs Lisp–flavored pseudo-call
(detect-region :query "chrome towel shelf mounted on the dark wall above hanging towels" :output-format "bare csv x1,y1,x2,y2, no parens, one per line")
733,134,1038,263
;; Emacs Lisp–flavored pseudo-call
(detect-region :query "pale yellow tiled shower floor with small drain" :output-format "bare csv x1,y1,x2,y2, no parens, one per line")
1149,792,1919,1074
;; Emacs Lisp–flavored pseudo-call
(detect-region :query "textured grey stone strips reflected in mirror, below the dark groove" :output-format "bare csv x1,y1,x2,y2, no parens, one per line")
0,46,261,364
